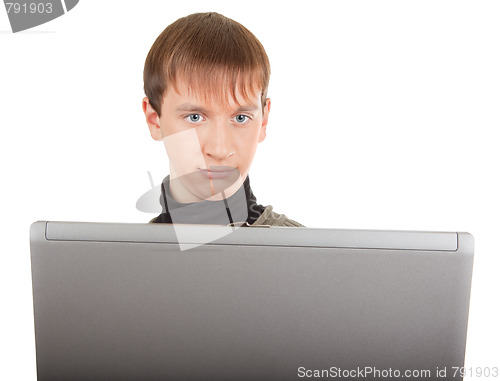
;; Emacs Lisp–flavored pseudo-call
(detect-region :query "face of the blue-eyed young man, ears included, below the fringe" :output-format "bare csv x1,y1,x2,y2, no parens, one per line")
143,82,270,203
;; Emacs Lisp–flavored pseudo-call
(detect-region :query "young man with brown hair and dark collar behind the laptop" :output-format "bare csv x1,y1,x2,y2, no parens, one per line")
142,12,303,227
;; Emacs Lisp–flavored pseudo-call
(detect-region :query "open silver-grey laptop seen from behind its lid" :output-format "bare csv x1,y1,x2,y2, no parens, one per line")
30,221,474,381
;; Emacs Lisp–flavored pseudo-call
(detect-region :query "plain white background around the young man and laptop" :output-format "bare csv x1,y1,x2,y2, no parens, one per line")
0,0,500,380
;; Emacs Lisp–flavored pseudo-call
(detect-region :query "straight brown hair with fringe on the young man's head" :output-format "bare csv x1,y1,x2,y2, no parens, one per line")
144,12,271,115
